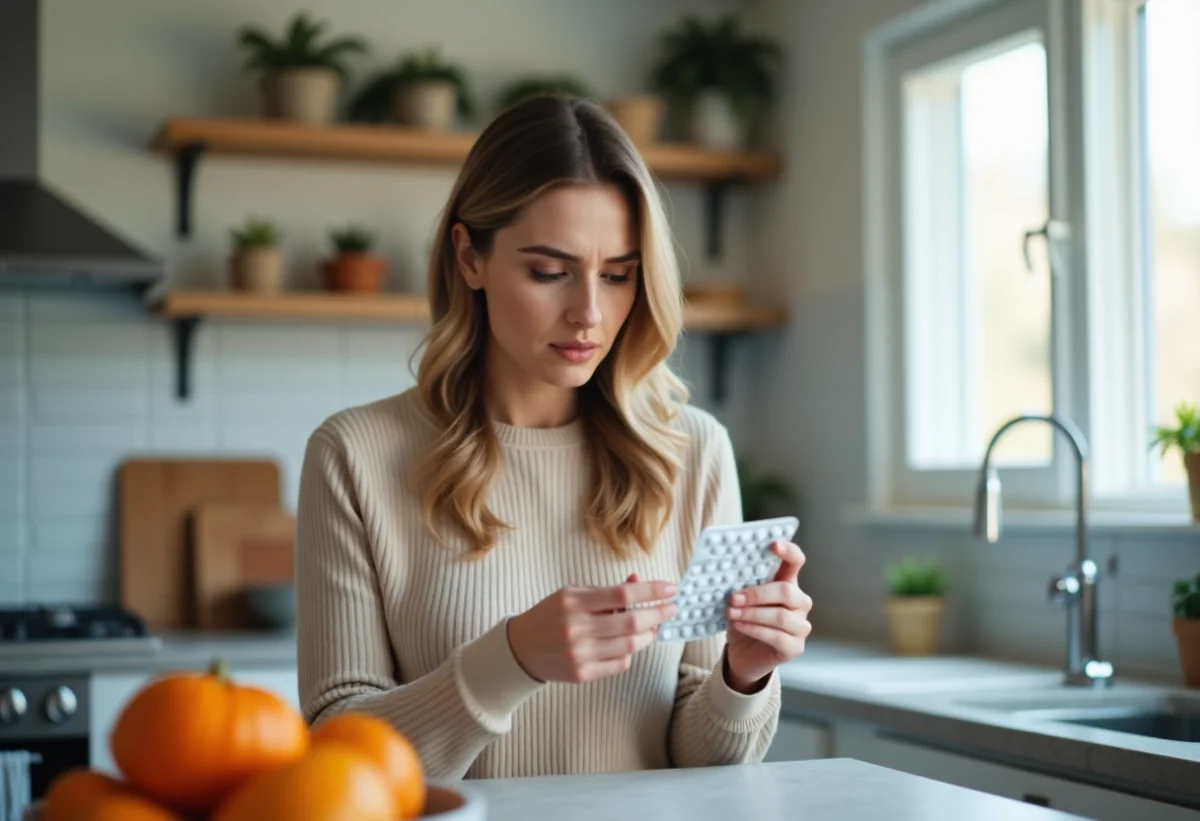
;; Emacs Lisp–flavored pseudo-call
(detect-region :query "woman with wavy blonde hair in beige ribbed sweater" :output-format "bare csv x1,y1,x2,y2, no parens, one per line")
296,97,811,779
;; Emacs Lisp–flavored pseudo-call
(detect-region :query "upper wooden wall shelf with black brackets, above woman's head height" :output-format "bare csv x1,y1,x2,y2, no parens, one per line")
152,118,784,257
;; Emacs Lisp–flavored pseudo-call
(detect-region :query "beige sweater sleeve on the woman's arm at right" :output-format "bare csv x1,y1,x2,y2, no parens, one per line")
670,427,780,767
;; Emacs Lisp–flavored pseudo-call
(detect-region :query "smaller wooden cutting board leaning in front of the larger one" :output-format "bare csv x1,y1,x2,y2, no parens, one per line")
192,504,295,630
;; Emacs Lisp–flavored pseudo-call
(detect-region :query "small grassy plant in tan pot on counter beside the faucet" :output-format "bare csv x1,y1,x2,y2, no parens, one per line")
884,556,947,655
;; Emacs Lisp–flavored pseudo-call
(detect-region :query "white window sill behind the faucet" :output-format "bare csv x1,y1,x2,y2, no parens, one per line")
842,505,1200,540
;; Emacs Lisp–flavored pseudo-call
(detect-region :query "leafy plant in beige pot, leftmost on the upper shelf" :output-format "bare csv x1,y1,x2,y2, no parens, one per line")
238,12,366,124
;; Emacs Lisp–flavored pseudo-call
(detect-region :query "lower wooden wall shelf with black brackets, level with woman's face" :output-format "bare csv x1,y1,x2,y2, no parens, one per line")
154,290,787,401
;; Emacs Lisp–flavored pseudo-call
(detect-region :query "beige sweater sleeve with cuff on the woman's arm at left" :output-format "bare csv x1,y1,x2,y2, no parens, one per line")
296,430,544,779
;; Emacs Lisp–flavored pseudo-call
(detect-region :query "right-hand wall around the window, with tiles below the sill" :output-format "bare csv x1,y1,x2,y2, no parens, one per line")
750,0,1200,677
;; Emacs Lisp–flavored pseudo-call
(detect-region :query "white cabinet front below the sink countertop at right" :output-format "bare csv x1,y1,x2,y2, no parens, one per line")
834,724,1200,821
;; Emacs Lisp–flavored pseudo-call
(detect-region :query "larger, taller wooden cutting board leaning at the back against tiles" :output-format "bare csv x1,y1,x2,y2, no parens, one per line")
119,459,283,630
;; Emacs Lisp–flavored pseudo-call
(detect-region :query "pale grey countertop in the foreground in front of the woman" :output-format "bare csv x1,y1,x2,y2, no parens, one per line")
462,759,1078,821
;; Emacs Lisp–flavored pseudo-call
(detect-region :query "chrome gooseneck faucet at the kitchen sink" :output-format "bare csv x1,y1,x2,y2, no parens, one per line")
974,414,1112,688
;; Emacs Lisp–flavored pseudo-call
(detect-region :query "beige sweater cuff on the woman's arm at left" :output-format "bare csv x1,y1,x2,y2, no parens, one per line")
458,617,546,726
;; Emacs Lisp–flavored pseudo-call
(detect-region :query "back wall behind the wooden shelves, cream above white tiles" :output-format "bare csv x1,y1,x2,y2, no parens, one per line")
0,0,756,606
